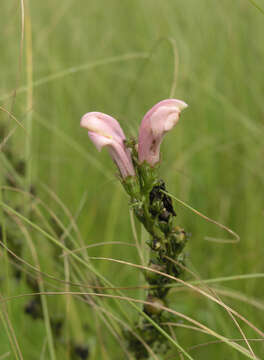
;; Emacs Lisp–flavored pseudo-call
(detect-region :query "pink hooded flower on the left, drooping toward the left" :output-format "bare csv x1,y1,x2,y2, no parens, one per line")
81,112,135,179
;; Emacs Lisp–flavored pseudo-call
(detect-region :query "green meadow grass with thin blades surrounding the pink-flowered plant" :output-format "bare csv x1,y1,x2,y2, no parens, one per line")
0,0,264,360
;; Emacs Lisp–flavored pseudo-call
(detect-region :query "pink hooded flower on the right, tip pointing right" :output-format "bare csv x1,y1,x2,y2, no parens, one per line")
138,99,188,166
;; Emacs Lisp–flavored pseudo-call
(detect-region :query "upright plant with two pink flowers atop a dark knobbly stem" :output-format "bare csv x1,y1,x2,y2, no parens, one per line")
81,99,188,359
